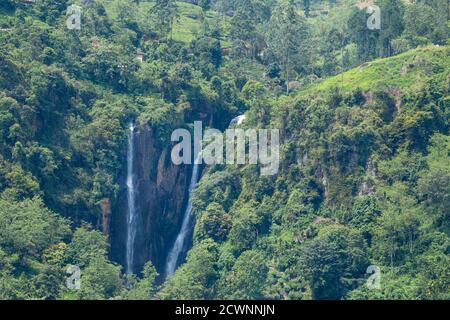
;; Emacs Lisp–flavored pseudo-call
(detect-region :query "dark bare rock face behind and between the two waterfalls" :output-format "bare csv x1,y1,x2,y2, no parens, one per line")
110,125,191,274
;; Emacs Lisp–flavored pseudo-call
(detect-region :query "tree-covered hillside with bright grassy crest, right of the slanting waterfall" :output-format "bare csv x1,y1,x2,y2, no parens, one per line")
161,47,450,299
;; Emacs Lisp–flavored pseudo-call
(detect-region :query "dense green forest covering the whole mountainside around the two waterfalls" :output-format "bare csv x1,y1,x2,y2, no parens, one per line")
0,0,450,300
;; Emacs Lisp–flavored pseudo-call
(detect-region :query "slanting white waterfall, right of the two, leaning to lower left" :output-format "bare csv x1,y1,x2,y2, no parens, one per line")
165,152,202,276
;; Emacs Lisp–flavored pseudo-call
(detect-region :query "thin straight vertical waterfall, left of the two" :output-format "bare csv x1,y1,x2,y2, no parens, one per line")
126,123,137,273
